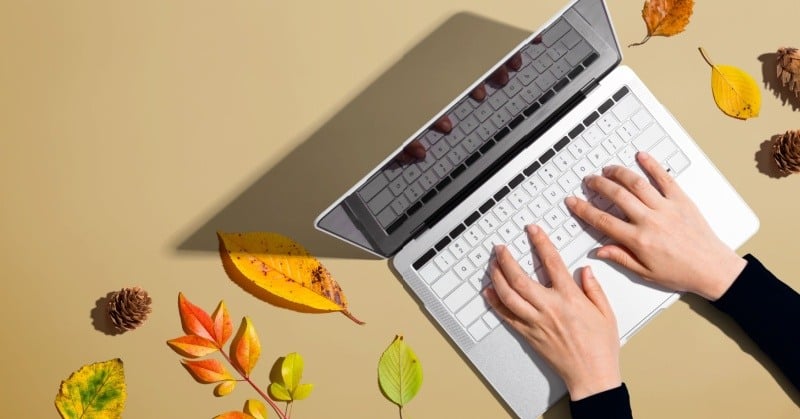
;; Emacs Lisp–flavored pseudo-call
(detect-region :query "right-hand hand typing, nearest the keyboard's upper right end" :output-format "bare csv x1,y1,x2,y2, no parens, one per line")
565,152,747,301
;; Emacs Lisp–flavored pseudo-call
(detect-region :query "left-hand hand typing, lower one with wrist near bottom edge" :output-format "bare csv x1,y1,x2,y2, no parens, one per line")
484,226,622,400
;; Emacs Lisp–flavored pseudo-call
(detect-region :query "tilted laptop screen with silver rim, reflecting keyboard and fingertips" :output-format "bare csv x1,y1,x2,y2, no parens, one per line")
316,0,621,257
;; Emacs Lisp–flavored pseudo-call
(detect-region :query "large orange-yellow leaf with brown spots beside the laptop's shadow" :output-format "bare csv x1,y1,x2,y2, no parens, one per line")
222,232,363,324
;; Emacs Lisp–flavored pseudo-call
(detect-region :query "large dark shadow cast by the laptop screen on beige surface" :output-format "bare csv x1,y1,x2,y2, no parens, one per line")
170,12,529,259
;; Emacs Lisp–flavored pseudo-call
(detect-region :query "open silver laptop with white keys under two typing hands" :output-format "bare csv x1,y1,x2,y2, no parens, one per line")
315,0,759,418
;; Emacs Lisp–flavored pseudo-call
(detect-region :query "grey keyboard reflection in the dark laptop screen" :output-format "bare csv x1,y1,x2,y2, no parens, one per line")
358,19,597,234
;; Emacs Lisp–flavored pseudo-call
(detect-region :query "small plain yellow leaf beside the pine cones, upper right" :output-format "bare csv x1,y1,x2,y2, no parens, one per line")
699,48,761,119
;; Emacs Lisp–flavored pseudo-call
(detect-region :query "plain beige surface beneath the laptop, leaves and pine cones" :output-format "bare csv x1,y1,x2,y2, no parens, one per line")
0,0,800,419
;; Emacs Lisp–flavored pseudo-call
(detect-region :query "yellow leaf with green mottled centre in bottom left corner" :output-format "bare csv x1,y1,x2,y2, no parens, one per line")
55,358,127,419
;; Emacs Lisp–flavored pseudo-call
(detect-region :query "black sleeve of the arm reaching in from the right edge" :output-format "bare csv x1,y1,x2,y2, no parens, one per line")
712,254,800,390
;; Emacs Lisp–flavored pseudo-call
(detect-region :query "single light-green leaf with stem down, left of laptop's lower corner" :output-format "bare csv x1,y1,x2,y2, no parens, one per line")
378,335,422,407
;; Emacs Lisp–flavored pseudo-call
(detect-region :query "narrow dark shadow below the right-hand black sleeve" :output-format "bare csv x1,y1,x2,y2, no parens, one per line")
681,293,800,407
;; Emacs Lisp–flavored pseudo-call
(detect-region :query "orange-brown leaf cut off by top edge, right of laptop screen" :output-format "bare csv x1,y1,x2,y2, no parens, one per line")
628,0,694,47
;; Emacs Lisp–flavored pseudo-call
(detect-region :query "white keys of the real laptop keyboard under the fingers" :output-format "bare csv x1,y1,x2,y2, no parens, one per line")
413,87,690,341
